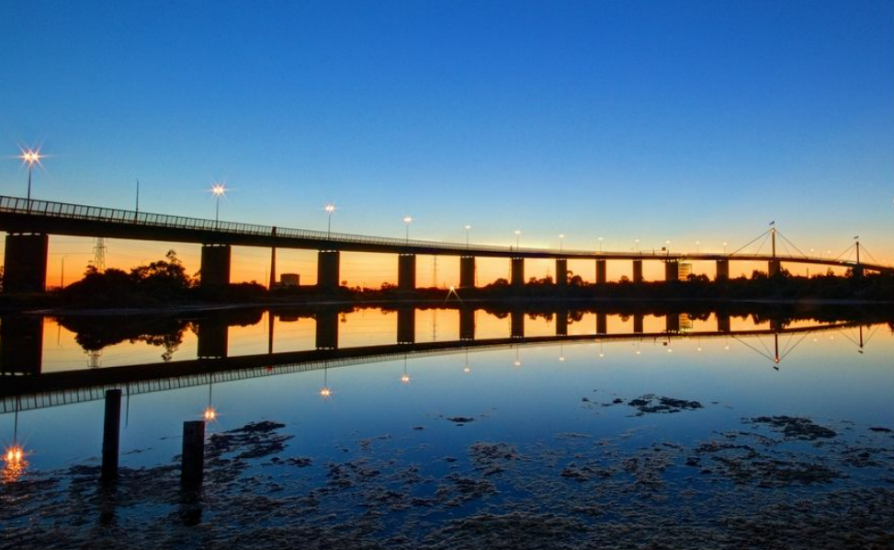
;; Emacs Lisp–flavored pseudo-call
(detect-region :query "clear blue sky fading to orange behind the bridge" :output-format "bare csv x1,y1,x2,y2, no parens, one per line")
0,0,894,284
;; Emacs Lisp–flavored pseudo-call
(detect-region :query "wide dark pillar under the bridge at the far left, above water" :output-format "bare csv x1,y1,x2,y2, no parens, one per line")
3,233,50,294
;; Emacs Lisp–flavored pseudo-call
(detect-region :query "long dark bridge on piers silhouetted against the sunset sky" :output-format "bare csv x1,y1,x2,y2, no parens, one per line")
0,197,894,292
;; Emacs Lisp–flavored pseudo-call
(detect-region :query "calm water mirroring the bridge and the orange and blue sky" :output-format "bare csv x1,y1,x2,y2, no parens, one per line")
0,308,894,547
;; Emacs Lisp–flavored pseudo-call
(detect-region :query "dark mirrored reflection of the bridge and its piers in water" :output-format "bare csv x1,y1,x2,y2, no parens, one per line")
0,307,863,414
